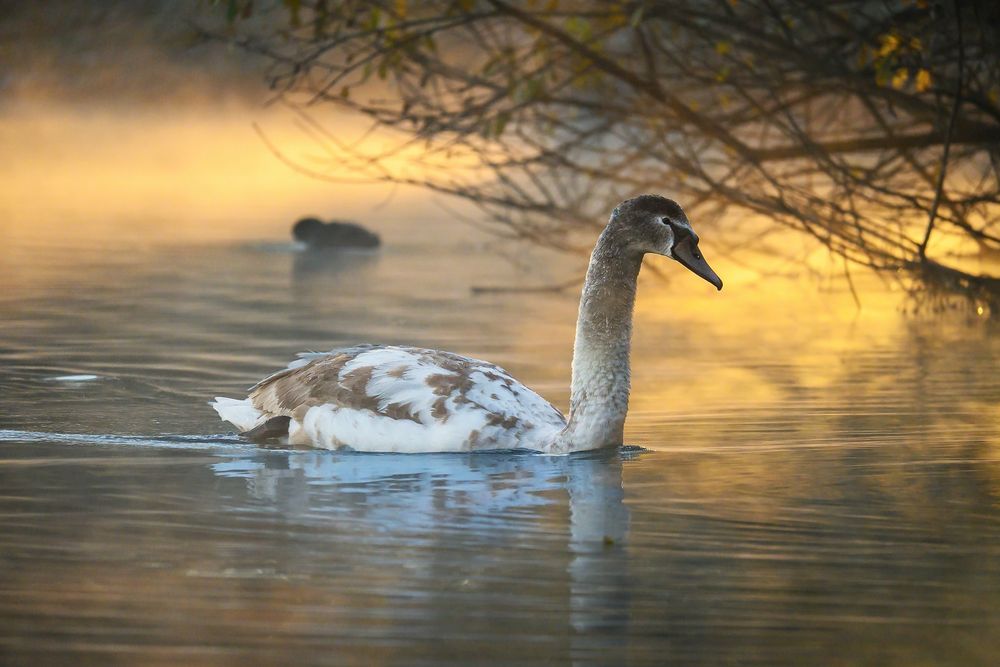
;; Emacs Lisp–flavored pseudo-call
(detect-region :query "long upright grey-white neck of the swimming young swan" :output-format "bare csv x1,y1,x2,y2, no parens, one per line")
557,229,642,451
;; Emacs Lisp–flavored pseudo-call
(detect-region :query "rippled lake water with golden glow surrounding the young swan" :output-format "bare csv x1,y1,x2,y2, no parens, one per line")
0,107,1000,666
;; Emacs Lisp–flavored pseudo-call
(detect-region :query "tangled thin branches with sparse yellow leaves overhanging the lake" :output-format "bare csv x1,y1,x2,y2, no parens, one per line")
215,0,1000,298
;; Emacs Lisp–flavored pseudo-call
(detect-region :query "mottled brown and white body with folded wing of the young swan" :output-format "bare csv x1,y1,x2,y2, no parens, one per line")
244,346,565,451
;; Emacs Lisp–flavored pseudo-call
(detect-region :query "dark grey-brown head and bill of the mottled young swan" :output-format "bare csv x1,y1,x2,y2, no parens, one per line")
608,195,722,289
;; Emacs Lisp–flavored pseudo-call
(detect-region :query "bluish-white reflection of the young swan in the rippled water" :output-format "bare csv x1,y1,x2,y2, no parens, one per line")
213,450,636,664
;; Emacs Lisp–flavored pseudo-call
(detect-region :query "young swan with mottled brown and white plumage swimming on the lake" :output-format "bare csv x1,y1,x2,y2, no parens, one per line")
212,195,722,454
